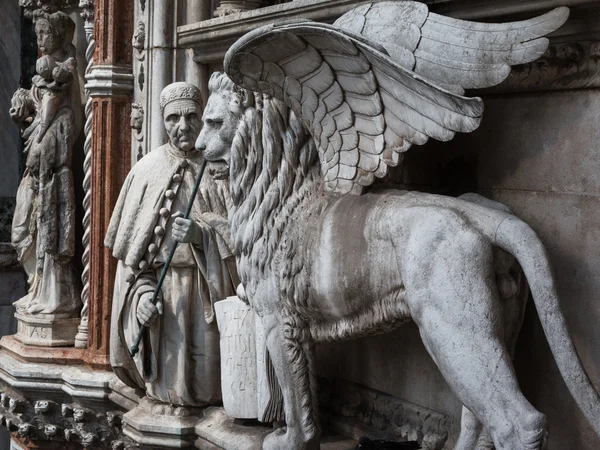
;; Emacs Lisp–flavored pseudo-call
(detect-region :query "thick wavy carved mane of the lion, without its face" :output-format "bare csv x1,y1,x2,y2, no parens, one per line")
230,94,322,298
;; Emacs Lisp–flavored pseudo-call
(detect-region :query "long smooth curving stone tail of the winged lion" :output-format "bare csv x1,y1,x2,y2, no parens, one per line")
493,216,600,436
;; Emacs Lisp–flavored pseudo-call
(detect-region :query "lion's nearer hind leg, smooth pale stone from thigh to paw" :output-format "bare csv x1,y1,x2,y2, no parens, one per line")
405,227,545,450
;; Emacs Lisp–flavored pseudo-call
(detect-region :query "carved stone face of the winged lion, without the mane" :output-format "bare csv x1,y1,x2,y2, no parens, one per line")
196,72,254,179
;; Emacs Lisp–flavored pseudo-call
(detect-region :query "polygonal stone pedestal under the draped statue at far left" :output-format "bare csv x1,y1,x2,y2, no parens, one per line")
15,313,79,347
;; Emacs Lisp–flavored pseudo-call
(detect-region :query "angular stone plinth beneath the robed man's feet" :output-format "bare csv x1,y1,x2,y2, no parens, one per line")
123,401,199,450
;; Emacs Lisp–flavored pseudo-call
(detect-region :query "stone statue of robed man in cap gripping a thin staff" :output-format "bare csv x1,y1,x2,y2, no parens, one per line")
105,83,237,412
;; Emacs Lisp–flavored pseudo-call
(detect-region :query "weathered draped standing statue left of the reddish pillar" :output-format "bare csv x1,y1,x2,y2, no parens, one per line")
10,10,82,317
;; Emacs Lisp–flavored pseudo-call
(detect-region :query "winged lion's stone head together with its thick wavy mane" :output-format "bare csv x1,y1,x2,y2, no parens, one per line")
196,74,321,297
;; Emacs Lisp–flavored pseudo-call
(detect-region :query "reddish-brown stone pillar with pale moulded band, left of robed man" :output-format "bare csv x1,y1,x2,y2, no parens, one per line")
86,0,133,366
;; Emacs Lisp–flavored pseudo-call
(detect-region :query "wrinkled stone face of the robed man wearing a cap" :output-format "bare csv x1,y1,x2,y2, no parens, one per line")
163,99,202,152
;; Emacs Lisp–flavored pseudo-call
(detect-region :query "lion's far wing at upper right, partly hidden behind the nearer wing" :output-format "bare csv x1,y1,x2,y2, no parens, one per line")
334,1,569,94
